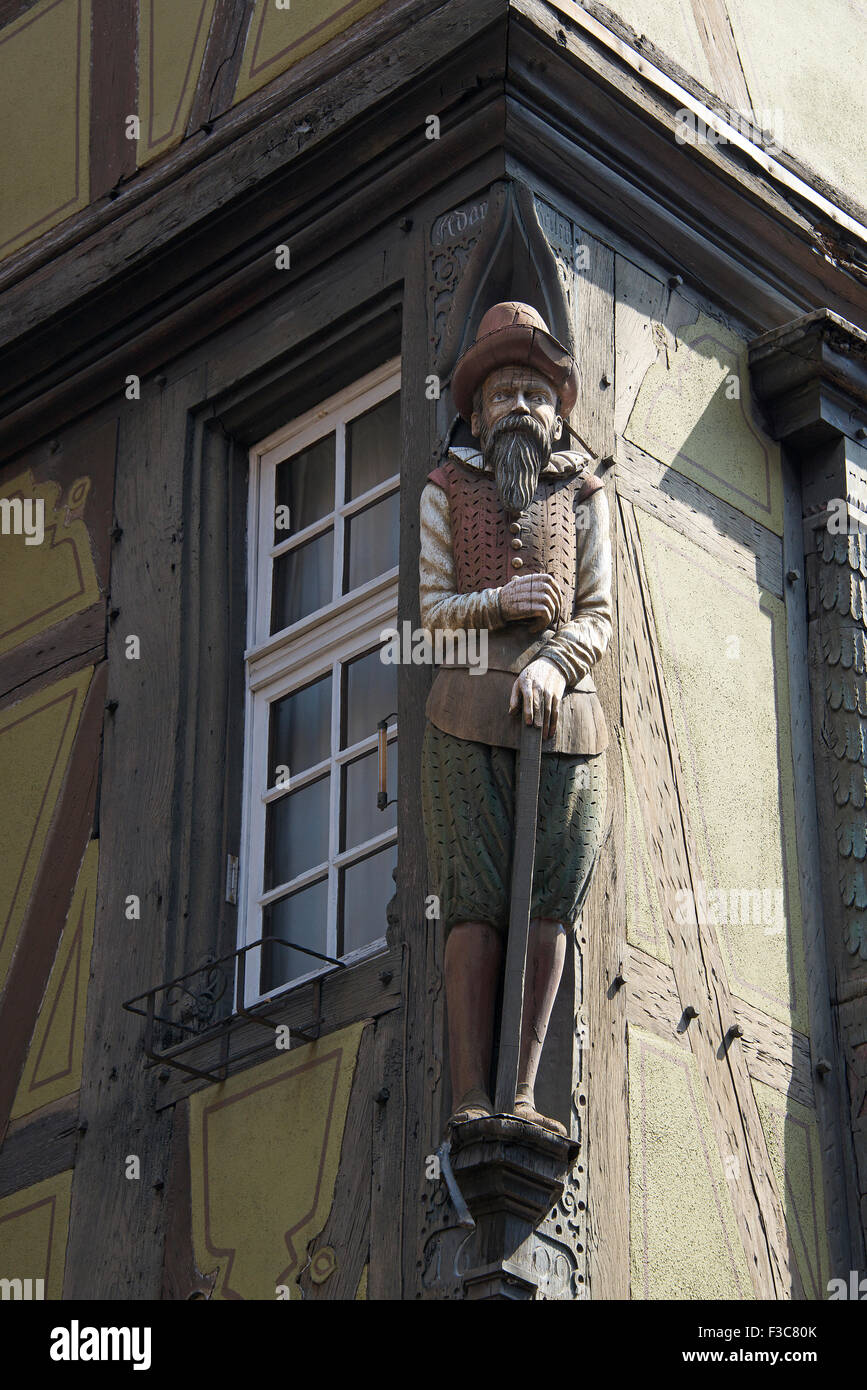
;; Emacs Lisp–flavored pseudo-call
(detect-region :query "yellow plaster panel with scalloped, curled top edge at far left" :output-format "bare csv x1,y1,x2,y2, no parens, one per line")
0,468,99,655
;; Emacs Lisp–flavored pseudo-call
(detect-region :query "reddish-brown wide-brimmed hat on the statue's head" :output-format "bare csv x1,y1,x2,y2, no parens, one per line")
452,300,578,423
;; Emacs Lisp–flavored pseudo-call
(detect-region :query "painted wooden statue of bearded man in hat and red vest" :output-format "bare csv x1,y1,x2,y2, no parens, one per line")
420,303,611,1134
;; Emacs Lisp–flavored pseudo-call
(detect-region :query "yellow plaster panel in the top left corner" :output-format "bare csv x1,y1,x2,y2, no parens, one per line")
0,0,90,257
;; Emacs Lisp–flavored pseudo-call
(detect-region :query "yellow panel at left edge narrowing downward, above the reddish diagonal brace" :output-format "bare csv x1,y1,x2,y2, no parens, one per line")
0,666,93,988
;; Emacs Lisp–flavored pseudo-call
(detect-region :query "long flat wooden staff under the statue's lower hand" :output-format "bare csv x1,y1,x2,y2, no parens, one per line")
495,720,542,1115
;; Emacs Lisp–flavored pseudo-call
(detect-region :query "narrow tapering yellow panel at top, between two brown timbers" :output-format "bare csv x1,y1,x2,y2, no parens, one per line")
138,0,217,164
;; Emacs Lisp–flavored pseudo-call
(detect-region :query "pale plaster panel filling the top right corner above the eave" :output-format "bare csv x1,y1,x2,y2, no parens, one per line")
727,0,867,207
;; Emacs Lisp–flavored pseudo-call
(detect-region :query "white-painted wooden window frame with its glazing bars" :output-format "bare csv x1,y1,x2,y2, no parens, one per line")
238,357,400,1008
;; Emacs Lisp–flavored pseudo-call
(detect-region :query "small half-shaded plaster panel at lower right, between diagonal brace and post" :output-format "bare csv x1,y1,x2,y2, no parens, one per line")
753,1081,829,1300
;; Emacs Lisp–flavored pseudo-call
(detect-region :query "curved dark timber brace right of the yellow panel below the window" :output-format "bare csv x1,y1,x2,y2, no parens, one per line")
296,1024,375,1301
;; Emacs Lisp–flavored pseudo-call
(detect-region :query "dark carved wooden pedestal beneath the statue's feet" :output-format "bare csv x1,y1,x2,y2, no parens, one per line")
452,1115,579,1300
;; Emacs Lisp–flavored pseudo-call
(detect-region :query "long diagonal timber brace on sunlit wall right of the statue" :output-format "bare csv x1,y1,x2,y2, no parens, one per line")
618,499,800,1298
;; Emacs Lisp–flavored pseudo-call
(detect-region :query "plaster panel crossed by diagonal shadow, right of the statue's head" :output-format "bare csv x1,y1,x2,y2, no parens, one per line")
625,314,782,535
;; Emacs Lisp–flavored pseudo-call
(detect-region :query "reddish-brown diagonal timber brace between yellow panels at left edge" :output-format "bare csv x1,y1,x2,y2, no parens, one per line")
0,663,107,1143
